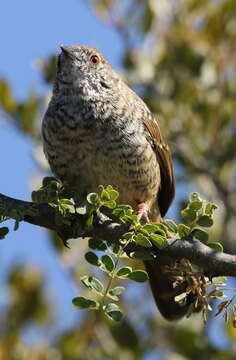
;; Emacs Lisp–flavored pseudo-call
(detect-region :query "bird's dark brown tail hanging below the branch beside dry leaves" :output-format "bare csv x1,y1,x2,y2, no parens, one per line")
144,256,195,320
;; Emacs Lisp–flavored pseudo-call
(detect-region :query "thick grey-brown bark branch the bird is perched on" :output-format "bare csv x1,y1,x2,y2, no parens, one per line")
0,194,236,277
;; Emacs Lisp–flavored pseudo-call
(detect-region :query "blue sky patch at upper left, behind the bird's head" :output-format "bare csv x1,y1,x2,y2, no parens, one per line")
0,0,122,97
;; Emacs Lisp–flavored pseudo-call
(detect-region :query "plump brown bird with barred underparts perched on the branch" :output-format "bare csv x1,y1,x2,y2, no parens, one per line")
42,45,193,320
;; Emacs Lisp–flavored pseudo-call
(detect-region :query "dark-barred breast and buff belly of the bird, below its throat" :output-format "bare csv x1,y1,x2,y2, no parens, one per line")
42,104,160,220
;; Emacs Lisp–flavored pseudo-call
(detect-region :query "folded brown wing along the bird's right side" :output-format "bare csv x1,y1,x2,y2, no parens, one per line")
144,118,175,216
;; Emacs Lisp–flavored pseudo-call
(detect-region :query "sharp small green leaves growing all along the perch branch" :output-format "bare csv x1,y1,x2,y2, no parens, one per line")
0,177,235,321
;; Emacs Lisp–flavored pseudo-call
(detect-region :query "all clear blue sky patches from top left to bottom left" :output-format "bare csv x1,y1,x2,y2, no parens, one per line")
0,0,122,341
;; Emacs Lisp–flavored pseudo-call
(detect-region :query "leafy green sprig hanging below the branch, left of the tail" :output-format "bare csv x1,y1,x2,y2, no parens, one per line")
72,238,147,321
